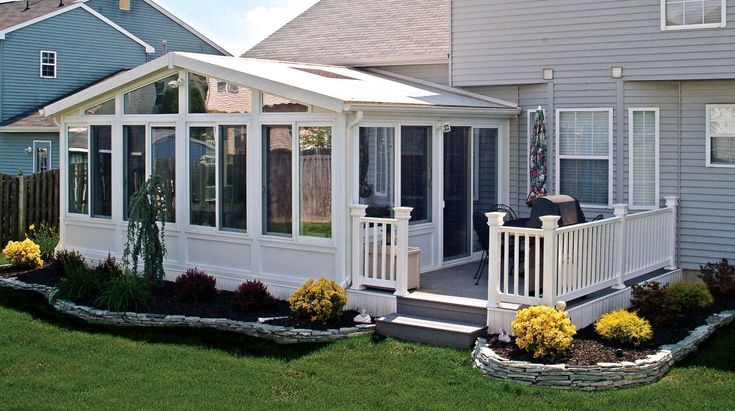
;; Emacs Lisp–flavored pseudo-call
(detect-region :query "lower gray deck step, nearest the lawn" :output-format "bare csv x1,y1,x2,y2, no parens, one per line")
376,313,487,348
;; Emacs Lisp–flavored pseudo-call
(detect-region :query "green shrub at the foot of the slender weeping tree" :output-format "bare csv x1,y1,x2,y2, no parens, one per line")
97,270,153,312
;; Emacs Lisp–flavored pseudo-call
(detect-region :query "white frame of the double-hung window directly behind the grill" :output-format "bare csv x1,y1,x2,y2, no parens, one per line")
554,107,615,209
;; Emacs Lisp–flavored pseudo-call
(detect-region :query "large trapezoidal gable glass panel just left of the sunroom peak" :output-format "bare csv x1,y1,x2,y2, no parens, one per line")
123,74,179,114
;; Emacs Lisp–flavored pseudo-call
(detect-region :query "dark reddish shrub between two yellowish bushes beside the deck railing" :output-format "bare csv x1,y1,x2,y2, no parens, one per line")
630,281,681,325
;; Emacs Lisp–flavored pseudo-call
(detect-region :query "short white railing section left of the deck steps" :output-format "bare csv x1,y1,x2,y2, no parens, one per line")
350,205,413,295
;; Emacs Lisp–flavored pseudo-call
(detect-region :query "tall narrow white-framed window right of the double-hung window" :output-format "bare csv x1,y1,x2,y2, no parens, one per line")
628,108,659,209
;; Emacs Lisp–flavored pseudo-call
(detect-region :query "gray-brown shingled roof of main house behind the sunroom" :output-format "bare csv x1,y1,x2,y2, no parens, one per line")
243,0,450,67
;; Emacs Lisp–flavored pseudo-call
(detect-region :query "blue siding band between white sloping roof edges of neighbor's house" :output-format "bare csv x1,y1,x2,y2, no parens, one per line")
87,0,222,59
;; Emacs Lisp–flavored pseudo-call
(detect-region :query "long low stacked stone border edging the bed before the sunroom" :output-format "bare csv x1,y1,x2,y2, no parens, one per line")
0,278,375,344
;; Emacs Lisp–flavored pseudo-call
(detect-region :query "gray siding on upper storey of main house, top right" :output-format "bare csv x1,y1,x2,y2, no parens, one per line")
451,0,735,86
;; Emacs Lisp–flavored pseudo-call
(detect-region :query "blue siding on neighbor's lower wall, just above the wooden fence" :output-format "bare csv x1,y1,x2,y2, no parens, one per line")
0,132,59,175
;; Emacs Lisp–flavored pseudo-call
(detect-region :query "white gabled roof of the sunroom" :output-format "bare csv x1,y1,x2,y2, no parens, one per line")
44,52,518,116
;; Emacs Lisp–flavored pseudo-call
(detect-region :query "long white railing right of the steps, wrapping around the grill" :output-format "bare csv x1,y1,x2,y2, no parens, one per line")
487,197,678,307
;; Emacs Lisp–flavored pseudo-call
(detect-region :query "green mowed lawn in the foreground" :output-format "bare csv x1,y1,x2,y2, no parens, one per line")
0,290,735,410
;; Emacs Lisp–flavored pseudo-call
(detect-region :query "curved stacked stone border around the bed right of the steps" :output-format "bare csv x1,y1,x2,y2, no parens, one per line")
472,310,735,391
